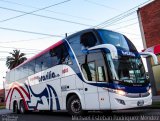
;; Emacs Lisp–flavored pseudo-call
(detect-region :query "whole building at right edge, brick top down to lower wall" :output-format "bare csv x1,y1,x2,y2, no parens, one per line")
137,0,160,95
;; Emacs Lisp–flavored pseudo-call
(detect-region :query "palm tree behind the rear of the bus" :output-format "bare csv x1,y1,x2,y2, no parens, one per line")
6,50,27,70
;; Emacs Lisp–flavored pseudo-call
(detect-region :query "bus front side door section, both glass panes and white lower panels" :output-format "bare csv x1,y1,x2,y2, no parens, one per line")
81,50,110,110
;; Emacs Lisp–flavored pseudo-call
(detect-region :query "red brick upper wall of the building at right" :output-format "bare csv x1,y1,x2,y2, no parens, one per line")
138,0,160,48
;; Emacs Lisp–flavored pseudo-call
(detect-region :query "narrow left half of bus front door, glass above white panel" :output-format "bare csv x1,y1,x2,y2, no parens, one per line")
81,53,99,110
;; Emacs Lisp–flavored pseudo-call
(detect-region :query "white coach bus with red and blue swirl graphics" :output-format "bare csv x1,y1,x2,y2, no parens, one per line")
5,29,156,115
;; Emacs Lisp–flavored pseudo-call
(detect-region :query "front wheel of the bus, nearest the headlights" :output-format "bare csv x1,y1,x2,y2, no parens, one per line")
67,95,84,116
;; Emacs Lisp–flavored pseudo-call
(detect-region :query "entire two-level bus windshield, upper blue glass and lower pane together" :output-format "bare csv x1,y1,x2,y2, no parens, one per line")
98,29,146,83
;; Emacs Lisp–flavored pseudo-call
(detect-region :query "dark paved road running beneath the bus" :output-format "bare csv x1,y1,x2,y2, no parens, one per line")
0,109,160,121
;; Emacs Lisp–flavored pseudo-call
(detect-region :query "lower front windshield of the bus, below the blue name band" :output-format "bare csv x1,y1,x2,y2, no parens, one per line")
106,53,146,83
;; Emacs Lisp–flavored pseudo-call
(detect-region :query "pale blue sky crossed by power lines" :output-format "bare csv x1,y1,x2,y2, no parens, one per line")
0,0,153,88
